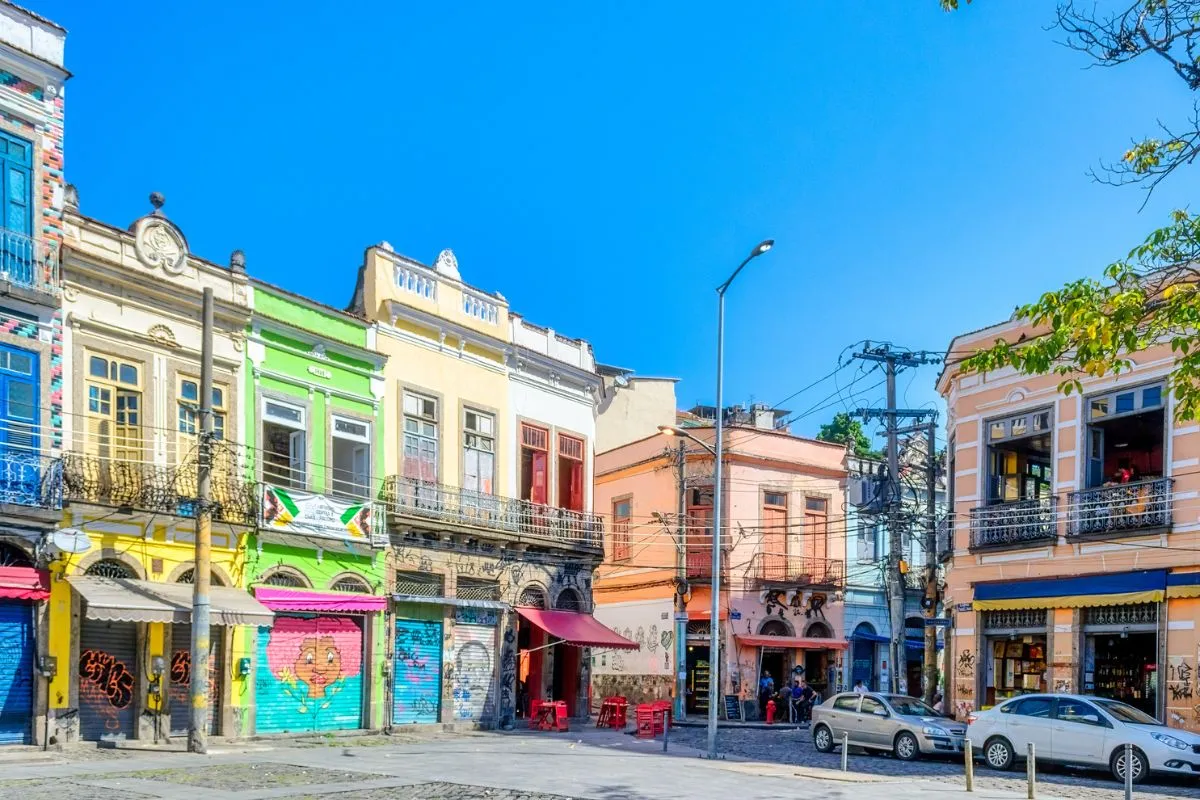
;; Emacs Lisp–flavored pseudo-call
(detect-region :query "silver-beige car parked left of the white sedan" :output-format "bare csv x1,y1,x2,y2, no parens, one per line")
812,692,967,762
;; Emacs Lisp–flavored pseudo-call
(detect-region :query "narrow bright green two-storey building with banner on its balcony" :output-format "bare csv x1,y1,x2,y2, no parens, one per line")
240,281,388,734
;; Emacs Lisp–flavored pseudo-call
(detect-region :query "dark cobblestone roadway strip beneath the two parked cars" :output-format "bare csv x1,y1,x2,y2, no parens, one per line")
671,728,1200,800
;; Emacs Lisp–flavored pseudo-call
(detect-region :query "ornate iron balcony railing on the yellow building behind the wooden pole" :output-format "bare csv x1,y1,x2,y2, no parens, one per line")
62,452,258,525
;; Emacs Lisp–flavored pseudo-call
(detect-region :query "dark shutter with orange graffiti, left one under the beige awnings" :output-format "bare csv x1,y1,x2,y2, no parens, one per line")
79,619,138,741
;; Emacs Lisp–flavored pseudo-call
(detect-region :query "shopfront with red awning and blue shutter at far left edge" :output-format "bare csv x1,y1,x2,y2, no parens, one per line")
0,566,49,745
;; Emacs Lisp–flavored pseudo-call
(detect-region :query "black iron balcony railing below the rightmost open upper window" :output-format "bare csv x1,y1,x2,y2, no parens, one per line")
1068,477,1174,539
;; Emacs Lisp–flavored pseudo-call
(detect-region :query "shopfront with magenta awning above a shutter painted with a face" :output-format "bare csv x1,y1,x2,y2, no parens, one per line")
254,587,388,734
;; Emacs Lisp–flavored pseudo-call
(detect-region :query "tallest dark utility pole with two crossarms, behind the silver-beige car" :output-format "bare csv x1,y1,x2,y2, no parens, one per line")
853,342,940,694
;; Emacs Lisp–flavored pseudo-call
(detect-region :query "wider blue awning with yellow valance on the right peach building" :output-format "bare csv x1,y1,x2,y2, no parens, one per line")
972,570,1166,610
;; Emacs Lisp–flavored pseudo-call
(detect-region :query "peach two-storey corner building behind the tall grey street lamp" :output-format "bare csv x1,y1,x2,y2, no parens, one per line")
592,388,847,714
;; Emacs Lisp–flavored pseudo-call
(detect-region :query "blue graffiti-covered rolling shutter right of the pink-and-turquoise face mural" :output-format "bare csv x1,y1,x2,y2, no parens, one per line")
391,619,442,724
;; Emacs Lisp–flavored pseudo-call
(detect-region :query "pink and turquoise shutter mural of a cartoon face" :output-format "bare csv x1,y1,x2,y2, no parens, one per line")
254,615,362,733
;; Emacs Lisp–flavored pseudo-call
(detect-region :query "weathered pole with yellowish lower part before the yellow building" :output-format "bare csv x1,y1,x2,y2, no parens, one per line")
187,288,212,753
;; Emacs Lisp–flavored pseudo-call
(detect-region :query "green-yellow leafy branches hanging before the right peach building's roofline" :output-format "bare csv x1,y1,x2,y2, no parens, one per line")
961,211,1200,420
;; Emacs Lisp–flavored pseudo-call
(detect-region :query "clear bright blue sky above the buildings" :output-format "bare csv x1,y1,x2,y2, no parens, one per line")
35,0,1195,441
